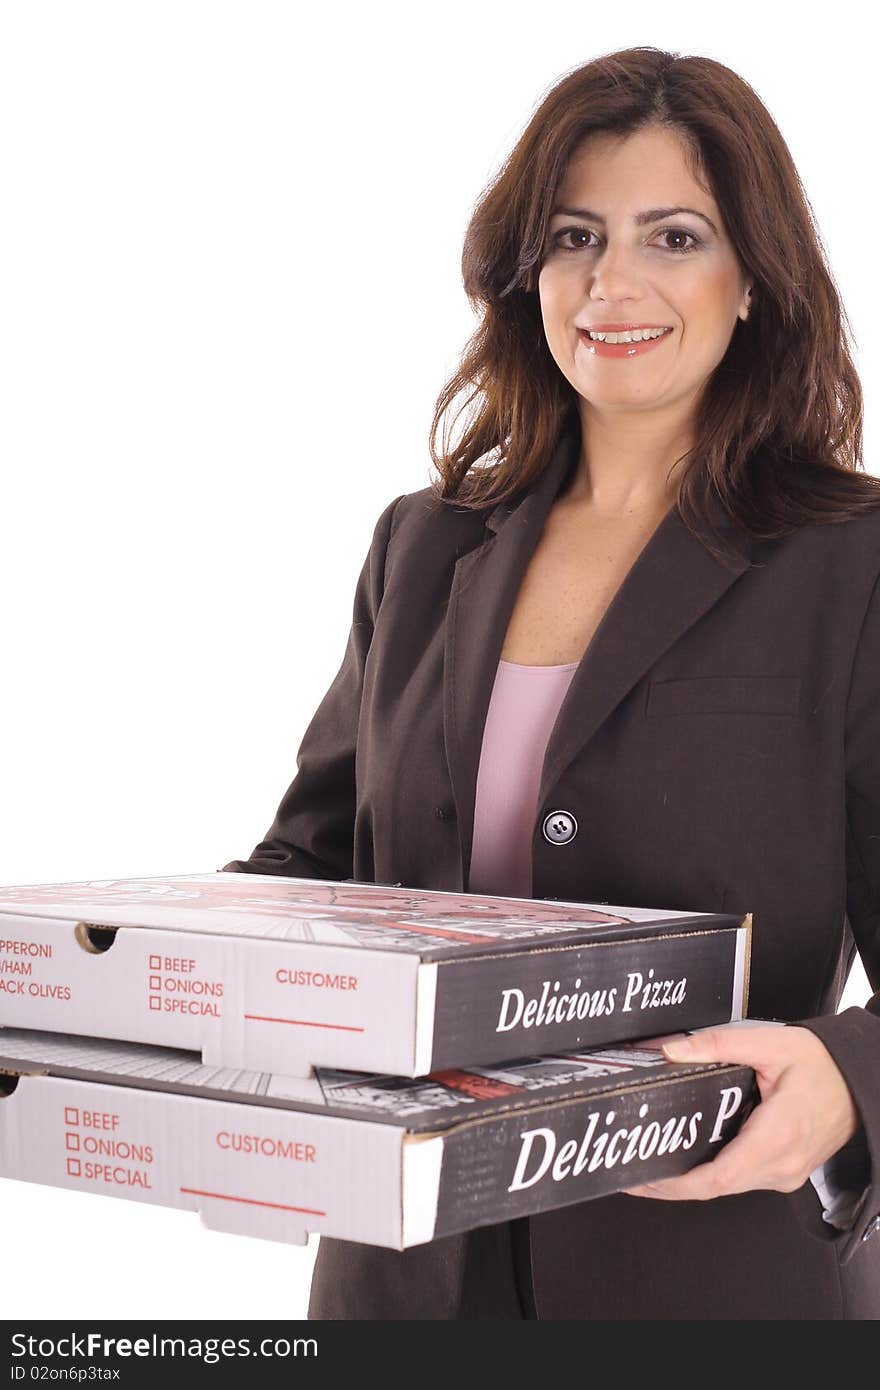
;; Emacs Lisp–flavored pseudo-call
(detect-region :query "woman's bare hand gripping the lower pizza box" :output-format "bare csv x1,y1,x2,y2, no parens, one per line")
626,1023,861,1201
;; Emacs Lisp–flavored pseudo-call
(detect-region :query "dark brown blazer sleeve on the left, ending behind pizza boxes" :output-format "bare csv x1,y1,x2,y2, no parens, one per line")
218,493,406,881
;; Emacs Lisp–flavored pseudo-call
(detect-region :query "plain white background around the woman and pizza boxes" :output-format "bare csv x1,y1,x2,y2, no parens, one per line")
0,0,880,1318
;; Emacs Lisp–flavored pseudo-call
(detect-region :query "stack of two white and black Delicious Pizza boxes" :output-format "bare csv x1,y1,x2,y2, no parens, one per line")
0,872,758,1250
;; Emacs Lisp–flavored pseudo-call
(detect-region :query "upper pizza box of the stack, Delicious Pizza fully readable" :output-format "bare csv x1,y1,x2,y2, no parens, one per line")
0,872,752,1077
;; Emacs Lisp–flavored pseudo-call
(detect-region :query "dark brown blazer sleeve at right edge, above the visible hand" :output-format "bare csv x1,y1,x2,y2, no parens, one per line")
799,556,880,1262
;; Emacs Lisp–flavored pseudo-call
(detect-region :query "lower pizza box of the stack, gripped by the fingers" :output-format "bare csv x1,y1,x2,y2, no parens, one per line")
0,1029,758,1250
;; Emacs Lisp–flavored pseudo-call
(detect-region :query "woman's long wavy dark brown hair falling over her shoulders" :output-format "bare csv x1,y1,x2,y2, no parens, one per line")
430,47,880,557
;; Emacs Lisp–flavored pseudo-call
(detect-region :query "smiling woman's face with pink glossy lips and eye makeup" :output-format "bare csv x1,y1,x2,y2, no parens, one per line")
538,126,751,410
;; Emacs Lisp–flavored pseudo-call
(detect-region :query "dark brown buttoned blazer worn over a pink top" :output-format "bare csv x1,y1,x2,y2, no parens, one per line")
224,413,880,1319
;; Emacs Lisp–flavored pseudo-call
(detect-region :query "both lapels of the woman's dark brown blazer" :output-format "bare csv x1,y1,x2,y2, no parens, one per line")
443,416,751,884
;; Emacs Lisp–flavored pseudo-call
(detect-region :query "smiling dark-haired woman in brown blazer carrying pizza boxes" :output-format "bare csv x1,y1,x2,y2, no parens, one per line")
225,49,880,1319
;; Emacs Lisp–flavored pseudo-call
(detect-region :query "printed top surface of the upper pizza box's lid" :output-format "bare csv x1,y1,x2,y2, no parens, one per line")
0,872,751,962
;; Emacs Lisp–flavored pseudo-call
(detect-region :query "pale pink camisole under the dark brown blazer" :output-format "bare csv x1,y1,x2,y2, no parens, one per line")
468,660,578,898
